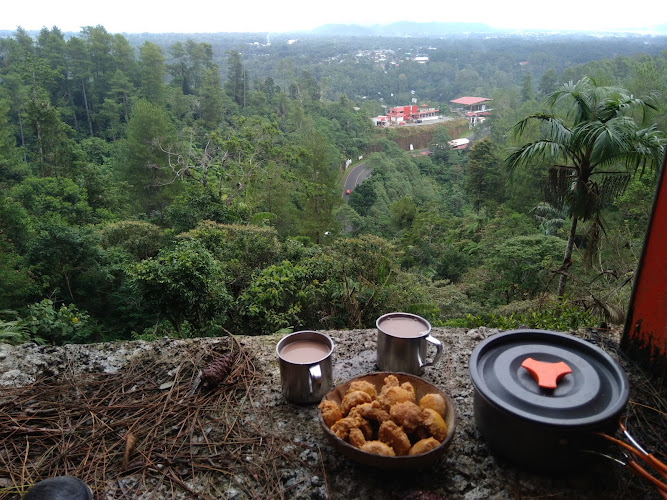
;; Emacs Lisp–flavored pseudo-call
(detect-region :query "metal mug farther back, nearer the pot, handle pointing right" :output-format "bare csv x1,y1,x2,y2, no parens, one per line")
375,312,442,375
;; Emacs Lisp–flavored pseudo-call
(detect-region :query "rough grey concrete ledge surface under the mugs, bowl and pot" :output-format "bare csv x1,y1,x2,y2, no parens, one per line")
0,327,657,500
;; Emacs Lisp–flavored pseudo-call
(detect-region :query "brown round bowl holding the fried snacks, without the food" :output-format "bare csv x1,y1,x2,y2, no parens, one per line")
318,372,457,470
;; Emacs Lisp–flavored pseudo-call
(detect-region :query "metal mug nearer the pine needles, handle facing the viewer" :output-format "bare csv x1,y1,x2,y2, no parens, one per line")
276,331,334,404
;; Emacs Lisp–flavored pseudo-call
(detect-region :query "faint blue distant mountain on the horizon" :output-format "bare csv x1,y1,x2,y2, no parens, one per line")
311,21,499,37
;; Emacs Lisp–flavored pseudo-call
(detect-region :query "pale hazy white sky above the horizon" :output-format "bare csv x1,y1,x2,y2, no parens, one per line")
0,0,667,33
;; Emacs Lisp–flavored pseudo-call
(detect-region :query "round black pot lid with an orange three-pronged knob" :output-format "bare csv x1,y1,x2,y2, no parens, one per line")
470,330,630,427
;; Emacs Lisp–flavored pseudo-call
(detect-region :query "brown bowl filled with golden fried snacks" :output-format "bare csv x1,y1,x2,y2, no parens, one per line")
318,372,456,469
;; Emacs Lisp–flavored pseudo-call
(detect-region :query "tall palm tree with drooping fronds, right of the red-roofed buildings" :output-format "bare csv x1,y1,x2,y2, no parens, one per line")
505,77,665,297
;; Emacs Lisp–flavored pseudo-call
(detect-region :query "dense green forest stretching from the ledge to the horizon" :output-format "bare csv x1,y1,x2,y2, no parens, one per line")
0,26,667,344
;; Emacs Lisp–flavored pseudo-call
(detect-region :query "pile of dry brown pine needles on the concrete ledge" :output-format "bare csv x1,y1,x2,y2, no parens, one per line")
0,337,320,499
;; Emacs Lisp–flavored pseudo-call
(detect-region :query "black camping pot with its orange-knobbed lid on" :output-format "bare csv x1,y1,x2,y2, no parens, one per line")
469,330,630,472
